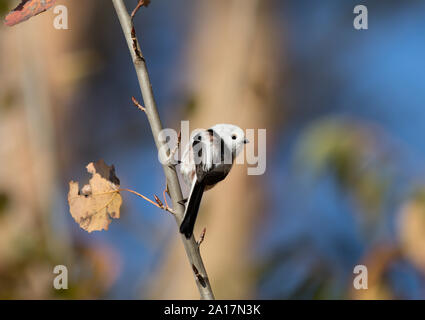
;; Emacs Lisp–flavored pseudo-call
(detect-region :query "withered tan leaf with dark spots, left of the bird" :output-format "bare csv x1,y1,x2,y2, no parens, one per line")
68,160,122,232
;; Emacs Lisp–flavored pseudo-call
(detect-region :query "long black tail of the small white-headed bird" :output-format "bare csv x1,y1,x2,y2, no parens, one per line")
180,178,205,239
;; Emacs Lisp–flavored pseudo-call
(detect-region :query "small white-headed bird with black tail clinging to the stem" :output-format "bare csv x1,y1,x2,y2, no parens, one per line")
180,124,249,239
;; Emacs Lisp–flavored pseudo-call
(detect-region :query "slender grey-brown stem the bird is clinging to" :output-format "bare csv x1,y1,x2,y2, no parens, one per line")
112,0,214,300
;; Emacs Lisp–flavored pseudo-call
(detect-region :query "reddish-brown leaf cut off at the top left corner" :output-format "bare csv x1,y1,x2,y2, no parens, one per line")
4,0,56,27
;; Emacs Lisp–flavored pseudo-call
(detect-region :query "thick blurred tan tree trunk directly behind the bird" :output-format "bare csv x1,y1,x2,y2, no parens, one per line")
153,0,276,299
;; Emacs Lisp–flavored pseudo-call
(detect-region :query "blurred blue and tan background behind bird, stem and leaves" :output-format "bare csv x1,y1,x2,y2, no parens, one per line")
0,0,425,299
